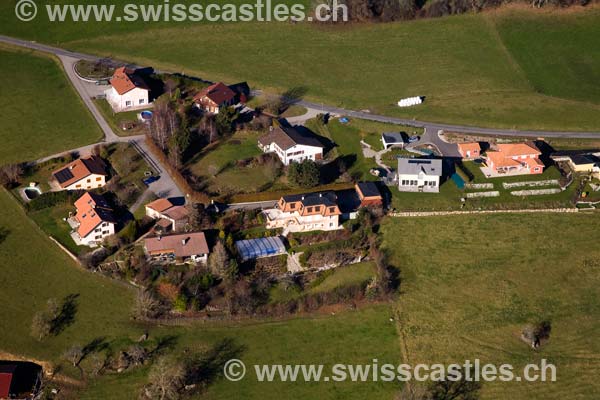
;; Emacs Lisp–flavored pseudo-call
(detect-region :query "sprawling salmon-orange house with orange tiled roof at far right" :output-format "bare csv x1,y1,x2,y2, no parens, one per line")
482,142,544,176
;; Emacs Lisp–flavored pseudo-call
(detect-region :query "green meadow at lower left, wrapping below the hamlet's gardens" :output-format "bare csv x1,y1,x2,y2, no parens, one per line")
0,191,400,399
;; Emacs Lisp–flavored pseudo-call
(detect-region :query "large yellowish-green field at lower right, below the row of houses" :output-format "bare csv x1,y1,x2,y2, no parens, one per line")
382,214,600,400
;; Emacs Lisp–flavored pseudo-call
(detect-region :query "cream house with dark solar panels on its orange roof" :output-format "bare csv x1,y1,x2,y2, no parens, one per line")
52,156,108,190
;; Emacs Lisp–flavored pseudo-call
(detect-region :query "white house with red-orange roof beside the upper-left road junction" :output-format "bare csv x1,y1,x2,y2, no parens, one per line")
104,67,150,112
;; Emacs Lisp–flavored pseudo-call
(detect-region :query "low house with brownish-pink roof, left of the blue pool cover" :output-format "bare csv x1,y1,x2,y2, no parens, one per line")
144,232,210,263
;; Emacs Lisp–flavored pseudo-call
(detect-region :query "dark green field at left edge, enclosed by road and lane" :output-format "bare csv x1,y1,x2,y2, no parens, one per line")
0,45,102,164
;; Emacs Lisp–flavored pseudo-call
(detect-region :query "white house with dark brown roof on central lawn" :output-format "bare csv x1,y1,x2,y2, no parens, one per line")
258,126,325,165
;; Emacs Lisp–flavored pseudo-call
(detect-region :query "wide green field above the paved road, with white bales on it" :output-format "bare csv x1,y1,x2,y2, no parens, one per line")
0,2,600,130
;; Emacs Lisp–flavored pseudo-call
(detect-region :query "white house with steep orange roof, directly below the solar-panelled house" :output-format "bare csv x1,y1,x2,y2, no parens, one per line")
70,192,117,247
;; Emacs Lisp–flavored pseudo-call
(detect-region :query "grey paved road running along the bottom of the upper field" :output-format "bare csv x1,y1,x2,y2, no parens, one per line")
0,35,600,139
